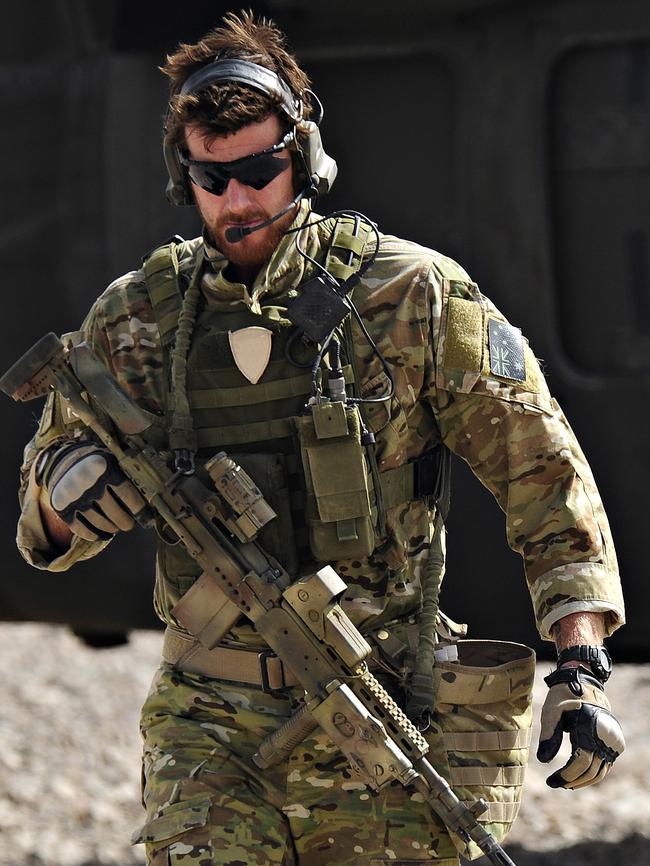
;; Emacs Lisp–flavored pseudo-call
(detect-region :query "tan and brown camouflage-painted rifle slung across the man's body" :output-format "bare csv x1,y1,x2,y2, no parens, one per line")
0,333,515,866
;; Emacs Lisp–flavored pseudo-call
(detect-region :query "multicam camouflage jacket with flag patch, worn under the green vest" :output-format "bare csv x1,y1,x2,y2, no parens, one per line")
18,207,624,643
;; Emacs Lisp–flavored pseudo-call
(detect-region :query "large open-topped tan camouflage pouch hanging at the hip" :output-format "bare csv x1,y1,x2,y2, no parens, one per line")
430,640,535,860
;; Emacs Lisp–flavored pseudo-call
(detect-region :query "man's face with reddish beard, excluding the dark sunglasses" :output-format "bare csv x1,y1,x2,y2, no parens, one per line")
185,115,295,279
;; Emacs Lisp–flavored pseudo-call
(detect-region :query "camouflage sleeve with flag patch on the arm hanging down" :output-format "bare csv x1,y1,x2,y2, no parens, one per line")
426,267,624,640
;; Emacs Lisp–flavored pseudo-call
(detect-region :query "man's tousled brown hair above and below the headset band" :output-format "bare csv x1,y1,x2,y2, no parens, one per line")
160,10,309,146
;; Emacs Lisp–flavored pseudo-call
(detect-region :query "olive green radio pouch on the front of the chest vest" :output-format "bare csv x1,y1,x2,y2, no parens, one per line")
294,403,375,562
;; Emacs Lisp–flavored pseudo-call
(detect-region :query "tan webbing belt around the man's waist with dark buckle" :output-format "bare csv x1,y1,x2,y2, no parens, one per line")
162,626,298,692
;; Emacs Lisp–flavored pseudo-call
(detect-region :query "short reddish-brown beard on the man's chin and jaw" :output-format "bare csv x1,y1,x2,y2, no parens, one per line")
199,201,295,273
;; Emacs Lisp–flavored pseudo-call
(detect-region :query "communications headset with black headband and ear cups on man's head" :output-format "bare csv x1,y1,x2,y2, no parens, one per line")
163,60,337,205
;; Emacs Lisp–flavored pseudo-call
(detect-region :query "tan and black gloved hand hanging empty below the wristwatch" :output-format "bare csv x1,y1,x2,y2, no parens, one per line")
537,667,625,789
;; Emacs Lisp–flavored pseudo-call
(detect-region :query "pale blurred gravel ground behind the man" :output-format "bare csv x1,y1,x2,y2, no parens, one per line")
0,624,650,866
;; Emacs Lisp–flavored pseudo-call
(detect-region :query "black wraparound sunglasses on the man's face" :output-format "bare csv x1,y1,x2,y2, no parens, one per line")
179,131,294,195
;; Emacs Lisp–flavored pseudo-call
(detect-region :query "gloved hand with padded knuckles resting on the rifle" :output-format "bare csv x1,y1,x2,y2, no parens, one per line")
37,442,145,541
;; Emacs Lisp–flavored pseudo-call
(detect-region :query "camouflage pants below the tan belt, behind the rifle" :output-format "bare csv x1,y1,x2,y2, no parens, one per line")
134,665,459,866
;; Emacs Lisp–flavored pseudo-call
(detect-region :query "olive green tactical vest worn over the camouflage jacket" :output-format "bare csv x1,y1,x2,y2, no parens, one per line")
144,219,442,620
